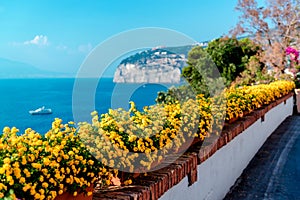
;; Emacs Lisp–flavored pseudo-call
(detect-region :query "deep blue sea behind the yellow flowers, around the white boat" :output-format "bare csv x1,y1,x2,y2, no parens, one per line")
0,78,172,134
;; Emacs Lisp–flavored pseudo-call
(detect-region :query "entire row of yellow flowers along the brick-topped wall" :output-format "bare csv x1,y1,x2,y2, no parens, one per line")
0,81,294,199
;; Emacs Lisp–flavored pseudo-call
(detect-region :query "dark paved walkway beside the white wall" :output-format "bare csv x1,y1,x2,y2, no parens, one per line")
224,115,300,200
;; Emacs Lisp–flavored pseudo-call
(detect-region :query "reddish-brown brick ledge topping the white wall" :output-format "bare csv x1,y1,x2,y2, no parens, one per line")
93,93,293,200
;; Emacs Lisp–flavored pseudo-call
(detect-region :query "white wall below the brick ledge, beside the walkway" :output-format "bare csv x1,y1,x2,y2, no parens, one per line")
160,97,293,200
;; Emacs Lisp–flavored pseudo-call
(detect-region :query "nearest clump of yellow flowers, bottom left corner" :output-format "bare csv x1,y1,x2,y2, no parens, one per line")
0,119,111,199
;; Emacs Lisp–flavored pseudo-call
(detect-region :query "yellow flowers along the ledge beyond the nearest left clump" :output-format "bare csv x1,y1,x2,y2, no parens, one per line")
78,81,294,178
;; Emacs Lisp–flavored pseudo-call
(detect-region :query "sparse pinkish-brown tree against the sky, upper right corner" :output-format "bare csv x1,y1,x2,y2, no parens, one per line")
232,0,300,73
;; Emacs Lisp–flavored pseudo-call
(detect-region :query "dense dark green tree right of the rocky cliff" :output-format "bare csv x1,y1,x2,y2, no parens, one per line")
182,37,263,96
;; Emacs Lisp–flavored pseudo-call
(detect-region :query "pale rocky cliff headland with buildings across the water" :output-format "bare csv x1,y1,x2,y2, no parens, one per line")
114,46,192,83
